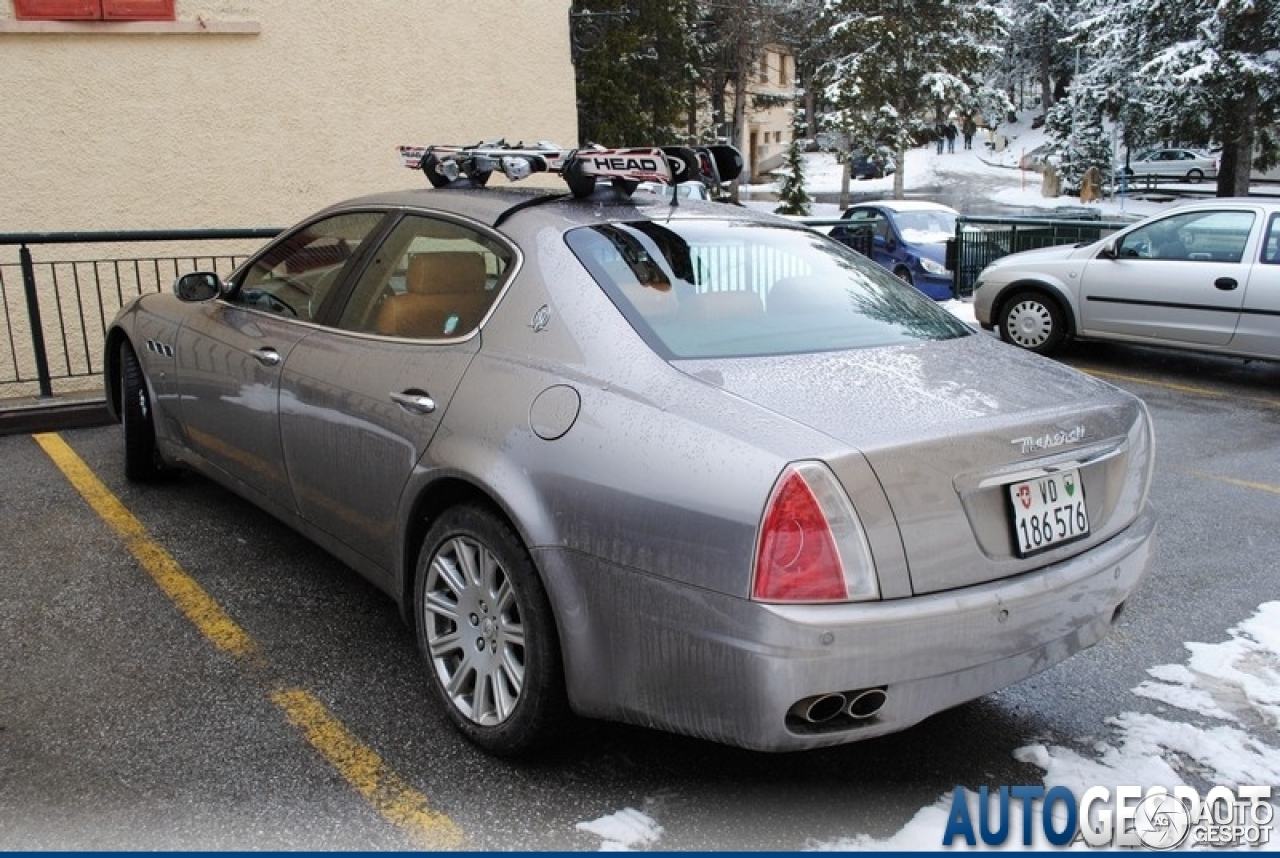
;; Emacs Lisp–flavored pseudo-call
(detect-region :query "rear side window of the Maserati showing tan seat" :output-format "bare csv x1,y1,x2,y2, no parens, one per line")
338,215,515,339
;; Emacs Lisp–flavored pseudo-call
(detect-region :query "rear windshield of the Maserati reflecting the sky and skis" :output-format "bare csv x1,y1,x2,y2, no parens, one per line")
566,220,973,359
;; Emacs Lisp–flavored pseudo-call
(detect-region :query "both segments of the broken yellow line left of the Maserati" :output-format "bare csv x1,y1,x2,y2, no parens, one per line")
33,433,465,849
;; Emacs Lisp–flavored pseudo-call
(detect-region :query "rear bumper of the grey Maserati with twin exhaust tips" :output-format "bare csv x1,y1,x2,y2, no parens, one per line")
535,508,1155,752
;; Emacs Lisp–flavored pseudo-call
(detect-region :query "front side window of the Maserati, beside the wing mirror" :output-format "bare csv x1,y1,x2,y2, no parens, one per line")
232,211,385,321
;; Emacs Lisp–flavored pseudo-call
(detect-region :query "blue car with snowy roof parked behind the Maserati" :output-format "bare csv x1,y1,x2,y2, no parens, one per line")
831,200,960,301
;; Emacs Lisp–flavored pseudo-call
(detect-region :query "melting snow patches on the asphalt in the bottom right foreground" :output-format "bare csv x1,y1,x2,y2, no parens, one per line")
577,602,1280,852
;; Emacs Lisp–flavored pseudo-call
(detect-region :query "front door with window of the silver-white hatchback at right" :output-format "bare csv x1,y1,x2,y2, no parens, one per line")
1080,209,1260,346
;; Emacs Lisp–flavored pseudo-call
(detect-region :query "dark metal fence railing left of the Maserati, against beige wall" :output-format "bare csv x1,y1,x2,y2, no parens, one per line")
0,228,280,400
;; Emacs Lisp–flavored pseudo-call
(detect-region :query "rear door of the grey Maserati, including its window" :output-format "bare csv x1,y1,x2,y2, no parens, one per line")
280,215,515,570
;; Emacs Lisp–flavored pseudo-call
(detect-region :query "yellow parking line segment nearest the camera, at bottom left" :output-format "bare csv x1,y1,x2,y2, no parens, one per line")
271,689,466,849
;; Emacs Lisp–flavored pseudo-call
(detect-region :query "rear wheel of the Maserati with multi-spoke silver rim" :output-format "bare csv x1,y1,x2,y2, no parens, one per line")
413,506,568,756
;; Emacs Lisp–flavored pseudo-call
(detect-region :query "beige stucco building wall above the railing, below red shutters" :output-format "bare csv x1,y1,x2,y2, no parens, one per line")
0,0,577,233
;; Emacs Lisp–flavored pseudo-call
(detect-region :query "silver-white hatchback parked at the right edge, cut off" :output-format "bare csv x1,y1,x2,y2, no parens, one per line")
973,197,1280,360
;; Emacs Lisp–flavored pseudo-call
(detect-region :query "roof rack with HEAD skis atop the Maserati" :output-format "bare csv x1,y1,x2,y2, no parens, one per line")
398,140,742,197
